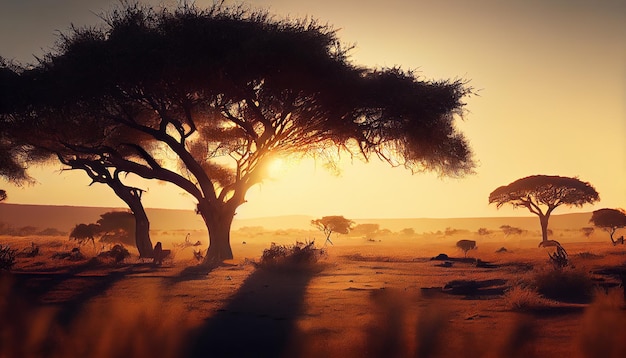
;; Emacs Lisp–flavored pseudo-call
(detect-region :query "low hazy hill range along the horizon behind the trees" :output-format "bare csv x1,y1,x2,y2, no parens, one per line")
0,203,591,232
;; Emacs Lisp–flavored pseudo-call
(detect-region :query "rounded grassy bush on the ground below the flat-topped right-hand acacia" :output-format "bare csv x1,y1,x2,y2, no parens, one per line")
534,268,594,303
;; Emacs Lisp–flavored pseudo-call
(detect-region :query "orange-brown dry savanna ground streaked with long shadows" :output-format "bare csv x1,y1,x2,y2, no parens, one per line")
0,228,626,357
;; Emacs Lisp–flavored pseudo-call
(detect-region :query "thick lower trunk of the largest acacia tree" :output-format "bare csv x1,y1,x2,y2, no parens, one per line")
198,203,235,266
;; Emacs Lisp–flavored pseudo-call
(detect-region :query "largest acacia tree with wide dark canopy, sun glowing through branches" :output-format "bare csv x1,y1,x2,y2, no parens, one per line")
13,5,474,263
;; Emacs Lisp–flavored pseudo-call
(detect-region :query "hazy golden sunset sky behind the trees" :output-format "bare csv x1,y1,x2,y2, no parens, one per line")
0,0,626,218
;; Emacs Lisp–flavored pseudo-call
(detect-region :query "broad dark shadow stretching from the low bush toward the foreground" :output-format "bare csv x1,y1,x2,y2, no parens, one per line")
188,269,314,357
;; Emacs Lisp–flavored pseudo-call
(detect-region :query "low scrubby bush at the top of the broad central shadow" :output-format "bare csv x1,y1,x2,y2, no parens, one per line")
259,241,326,268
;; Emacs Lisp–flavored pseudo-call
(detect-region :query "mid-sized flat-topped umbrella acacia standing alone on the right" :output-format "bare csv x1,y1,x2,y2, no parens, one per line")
489,175,600,243
